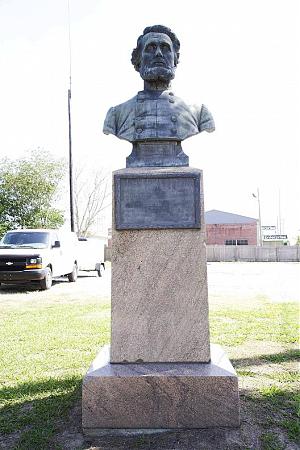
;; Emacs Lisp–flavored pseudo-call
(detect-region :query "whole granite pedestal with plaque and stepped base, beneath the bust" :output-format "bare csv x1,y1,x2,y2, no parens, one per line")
82,167,239,436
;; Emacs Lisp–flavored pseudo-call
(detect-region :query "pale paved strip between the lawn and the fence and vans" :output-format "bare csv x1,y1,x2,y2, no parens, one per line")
0,262,300,303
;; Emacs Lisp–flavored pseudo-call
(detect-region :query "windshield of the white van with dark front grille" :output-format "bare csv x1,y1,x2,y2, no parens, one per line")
0,231,49,248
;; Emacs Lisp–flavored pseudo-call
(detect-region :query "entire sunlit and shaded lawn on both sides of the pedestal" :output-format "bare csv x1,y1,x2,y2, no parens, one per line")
0,280,300,450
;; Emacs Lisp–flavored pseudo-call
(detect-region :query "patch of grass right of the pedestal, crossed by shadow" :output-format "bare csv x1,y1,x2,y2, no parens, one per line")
210,299,300,450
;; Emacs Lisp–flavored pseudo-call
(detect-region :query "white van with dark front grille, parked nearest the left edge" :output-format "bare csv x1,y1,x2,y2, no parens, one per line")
0,229,78,290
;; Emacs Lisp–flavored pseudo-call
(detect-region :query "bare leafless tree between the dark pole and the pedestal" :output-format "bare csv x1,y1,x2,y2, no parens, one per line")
74,167,111,236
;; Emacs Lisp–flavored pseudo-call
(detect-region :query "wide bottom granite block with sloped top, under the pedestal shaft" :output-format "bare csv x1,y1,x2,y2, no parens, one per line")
82,345,240,436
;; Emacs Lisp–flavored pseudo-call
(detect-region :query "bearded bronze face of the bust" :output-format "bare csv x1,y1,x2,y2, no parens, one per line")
140,33,175,81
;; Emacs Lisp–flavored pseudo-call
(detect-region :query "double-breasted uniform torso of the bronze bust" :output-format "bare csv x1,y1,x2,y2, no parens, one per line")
103,90,215,142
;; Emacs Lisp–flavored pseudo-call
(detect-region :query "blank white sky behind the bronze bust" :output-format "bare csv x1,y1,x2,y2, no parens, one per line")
0,0,300,241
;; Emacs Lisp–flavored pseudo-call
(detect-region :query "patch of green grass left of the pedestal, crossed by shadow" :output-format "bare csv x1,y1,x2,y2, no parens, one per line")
0,299,110,449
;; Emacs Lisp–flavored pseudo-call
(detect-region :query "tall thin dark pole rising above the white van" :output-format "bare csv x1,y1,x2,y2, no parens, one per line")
68,0,75,231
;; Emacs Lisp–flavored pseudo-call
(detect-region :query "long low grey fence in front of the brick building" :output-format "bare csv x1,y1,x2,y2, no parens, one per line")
207,245,300,262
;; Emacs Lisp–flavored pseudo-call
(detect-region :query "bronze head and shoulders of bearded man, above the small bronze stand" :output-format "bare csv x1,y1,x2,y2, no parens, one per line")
103,25,215,165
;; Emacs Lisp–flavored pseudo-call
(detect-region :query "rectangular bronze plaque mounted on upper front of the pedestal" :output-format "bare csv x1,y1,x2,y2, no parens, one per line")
115,172,200,230
